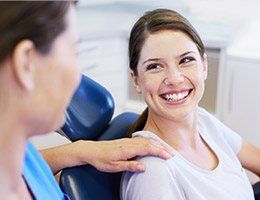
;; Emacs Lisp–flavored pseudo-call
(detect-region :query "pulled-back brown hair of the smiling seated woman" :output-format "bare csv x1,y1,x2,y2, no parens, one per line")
128,9,205,137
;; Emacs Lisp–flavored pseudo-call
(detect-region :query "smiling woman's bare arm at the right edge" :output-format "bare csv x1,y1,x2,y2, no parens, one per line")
237,141,260,177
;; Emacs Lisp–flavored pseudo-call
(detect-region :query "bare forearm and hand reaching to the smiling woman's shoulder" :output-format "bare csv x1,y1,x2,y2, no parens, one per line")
40,137,173,174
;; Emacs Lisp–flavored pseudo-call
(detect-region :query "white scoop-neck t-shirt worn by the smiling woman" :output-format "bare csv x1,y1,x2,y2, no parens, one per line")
121,108,254,200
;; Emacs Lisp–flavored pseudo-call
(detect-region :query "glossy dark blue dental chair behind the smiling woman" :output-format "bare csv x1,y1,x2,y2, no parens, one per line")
60,76,138,200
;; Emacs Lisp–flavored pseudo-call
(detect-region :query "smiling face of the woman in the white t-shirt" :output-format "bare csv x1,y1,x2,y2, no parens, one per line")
131,30,207,119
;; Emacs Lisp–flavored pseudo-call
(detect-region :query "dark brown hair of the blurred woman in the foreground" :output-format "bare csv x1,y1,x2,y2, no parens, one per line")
0,1,73,63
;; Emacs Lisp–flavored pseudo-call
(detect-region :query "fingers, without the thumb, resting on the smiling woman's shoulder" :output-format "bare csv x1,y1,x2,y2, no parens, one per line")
126,137,174,159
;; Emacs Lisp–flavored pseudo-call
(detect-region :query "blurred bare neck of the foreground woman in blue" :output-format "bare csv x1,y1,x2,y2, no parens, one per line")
0,109,28,196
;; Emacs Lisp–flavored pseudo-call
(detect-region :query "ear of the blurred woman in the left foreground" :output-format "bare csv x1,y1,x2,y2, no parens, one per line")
12,40,35,91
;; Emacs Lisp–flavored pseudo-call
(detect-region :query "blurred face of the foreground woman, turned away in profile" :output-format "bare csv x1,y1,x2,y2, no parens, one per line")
33,6,81,133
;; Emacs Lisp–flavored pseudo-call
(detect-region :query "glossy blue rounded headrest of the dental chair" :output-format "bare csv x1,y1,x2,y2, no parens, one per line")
61,75,114,141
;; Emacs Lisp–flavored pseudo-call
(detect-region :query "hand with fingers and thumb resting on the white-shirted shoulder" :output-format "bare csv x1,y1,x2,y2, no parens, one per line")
78,137,173,172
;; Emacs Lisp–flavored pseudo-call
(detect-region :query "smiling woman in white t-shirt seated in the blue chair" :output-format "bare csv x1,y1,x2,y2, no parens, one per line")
121,9,260,200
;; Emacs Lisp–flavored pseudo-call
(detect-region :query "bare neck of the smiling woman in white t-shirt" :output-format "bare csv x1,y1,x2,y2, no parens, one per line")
144,109,200,150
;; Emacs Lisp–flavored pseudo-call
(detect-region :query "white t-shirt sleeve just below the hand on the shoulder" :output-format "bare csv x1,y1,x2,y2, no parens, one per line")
121,157,185,200
